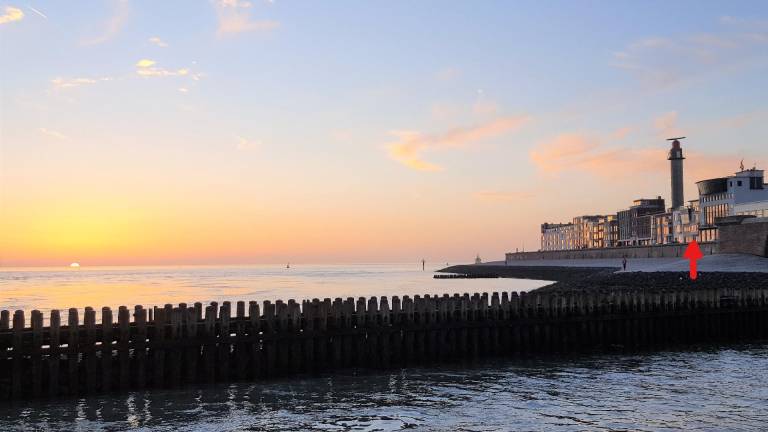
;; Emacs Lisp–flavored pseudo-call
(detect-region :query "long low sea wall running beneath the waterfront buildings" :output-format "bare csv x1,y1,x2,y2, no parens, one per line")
506,242,719,263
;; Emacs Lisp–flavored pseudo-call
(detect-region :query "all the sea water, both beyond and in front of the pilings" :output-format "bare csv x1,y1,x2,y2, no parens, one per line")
0,263,768,432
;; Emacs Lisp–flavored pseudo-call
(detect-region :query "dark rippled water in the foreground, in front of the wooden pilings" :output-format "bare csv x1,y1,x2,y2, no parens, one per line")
0,343,768,431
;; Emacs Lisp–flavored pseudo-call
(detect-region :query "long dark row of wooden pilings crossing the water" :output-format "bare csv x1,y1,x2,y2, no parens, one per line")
0,287,768,400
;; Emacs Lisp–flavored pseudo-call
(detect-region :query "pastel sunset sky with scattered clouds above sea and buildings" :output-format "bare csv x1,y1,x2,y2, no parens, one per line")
0,0,768,266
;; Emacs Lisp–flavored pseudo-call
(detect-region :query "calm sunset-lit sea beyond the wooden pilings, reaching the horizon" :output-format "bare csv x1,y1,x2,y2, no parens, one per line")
0,264,549,319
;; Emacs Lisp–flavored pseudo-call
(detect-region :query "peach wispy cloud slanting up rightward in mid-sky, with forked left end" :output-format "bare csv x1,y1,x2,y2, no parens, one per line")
387,115,529,171
